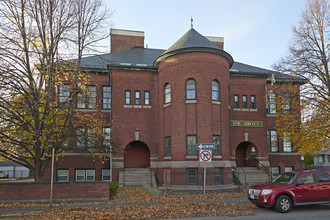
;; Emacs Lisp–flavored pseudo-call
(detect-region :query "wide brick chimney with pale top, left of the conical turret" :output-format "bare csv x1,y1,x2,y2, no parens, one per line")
110,29,144,53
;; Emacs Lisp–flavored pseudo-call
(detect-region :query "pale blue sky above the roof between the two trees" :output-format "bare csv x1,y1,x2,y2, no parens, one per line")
105,0,306,69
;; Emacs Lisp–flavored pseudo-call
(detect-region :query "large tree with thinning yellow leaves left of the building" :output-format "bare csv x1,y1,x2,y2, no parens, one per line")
0,0,110,182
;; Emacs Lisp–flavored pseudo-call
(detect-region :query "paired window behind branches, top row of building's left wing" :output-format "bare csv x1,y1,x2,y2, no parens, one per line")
77,86,96,109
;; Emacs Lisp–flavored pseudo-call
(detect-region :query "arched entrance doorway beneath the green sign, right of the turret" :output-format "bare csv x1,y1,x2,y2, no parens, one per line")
235,141,258,167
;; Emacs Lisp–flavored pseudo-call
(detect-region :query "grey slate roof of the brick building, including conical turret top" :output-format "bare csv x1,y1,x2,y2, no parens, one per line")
76,28,304,83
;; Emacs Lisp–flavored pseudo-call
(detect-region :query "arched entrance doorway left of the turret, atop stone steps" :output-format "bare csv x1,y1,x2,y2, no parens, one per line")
124,141,150,168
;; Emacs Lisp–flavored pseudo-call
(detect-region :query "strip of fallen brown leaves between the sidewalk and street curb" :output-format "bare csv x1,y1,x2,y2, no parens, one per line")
25,203,254,219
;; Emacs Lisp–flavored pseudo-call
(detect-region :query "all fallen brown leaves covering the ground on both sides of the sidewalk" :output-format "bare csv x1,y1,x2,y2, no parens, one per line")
0,187,254,219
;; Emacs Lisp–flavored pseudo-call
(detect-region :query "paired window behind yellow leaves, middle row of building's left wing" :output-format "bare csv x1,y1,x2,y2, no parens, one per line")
76,128,96,151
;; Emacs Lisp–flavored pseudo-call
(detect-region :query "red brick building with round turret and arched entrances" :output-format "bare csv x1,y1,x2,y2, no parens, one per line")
50,28,304,184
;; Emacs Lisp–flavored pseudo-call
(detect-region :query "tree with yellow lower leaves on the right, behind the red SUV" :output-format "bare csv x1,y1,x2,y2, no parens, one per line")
274,0,330,154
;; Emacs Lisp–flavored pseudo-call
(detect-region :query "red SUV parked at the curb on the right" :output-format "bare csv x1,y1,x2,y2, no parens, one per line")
248,170,330,213
